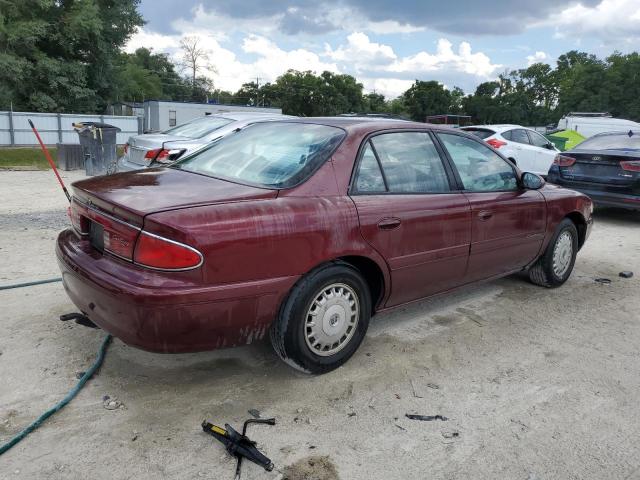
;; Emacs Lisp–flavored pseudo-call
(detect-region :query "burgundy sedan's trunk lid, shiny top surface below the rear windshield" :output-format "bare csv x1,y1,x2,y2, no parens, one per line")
73,168,278,227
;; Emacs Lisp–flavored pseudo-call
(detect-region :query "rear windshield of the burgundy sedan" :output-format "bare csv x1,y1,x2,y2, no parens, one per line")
173,122,346,188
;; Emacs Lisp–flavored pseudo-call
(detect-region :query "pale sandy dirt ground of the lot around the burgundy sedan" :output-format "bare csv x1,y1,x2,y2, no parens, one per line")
0,172,640,480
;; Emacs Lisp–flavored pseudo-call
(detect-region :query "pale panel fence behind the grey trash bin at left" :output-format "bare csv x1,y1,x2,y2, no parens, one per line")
0,112,142,146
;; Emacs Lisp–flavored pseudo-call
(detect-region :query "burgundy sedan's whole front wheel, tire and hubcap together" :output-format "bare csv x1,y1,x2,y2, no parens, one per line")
529,218,578,288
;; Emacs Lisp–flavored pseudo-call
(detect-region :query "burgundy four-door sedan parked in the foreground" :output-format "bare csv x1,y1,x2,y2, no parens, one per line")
57,118,592,373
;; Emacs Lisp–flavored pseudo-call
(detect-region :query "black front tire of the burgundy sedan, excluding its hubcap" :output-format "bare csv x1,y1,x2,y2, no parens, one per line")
529,218,578,288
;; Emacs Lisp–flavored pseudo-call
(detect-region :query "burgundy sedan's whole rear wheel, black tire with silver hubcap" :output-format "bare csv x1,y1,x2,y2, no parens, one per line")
270,263,371,373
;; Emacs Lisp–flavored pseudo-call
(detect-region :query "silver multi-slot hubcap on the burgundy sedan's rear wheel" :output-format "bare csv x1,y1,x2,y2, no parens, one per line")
305,283,360,357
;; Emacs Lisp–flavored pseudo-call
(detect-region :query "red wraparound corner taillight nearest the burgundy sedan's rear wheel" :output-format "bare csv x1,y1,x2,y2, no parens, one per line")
133,232,202,270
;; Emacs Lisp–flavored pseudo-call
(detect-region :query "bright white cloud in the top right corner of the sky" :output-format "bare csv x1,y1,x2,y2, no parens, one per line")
532,0,640,49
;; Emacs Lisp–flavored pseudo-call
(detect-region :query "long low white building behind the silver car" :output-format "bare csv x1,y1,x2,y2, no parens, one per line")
143,100,282,132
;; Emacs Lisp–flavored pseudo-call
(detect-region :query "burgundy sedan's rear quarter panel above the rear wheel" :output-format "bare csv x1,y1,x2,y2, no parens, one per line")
144,162,388,285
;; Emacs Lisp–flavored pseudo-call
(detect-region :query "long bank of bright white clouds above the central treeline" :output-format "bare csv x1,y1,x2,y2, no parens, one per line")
126,27,501,98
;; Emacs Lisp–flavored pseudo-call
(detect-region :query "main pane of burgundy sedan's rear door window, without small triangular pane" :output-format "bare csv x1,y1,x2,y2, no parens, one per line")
364,132,450,193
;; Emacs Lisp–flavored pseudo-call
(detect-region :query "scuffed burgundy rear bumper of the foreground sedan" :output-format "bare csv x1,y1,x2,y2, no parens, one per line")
56,230,298,353
